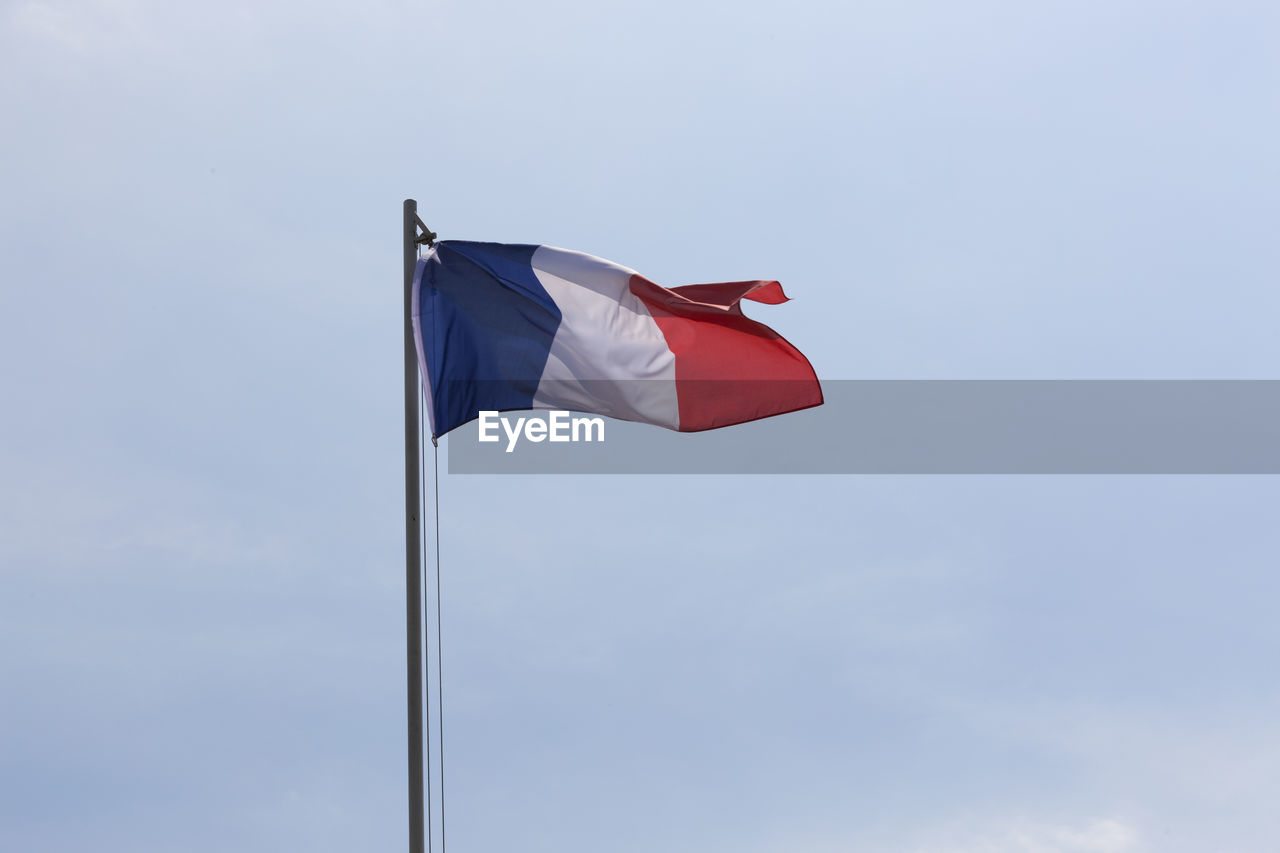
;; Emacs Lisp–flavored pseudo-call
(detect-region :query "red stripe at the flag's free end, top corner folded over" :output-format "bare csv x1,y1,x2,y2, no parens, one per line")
631,275,822,432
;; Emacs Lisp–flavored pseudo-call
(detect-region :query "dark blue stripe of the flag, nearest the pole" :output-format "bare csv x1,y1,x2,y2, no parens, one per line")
419,240,561,435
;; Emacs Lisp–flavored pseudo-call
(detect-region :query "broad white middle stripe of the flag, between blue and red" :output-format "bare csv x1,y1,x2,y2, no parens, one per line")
532,246,680,429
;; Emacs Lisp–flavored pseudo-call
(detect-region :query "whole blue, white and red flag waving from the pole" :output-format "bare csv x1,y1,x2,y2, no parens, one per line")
412,241,822,435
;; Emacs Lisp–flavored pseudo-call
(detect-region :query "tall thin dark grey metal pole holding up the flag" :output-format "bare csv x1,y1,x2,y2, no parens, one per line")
404,199,424,853
